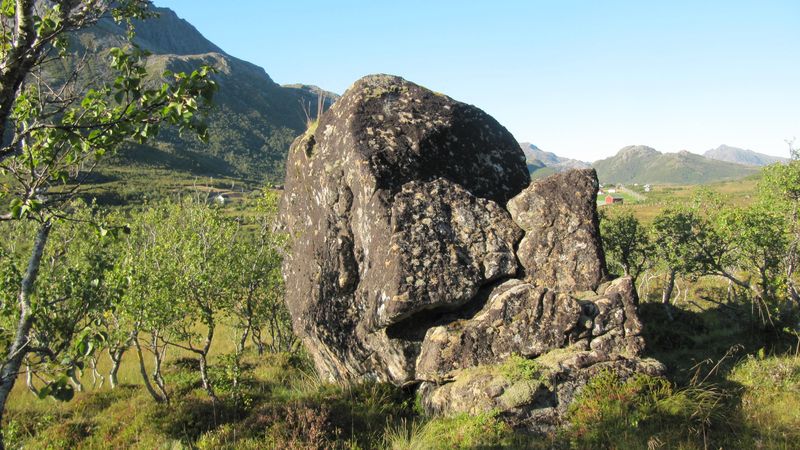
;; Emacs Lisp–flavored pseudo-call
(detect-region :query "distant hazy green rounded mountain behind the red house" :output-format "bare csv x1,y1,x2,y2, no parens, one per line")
592,145,759,184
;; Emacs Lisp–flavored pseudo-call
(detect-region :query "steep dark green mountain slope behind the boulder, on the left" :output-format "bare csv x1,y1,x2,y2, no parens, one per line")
65,7,337,182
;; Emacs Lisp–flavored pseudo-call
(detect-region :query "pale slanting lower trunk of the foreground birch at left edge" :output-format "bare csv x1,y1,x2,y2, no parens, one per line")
0,222,51,450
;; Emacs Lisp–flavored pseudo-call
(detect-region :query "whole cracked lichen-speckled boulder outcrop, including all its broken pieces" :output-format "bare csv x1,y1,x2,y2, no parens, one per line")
281,75,659,432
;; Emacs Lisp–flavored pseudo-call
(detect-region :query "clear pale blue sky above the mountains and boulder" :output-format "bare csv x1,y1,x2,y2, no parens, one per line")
155,0,800,161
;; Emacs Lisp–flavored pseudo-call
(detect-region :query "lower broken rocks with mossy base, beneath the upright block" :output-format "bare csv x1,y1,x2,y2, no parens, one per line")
417,277,664,431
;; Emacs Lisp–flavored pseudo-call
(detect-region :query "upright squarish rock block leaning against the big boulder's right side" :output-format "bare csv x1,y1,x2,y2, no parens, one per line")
508,169,607,291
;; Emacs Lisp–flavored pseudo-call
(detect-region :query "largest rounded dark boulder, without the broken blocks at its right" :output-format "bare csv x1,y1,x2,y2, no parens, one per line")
281,75,529,383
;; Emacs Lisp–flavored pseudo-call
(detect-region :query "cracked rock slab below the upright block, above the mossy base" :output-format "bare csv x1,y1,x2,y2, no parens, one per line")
417,278,644,382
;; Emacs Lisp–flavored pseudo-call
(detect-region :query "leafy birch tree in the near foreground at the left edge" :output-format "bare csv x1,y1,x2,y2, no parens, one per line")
0,0,215,442
